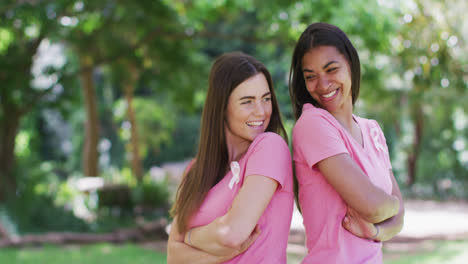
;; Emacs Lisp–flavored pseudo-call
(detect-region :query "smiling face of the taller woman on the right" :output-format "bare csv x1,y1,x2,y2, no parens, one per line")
302,46,352,114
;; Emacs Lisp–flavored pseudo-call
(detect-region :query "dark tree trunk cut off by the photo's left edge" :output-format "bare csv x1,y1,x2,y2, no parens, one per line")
0,105,21,202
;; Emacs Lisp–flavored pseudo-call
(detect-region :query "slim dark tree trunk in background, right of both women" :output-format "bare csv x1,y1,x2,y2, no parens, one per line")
407,105,424,186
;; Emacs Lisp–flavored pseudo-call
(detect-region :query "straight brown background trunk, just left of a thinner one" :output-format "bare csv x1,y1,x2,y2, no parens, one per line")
80,55,99,176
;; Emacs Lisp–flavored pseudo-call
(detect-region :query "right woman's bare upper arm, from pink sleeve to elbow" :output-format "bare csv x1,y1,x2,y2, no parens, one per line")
317,153,400,223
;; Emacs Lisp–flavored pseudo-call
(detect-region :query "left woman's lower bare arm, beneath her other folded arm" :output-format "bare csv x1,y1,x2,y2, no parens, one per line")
167,219,257,264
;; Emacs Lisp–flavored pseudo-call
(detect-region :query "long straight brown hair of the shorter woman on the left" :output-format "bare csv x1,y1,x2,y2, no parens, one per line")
171,52,287,233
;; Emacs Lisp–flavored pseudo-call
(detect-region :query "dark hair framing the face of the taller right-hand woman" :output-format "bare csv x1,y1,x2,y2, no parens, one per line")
289,23,361,120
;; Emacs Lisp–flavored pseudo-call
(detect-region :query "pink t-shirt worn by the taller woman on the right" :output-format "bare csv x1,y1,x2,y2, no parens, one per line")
293,104,392,264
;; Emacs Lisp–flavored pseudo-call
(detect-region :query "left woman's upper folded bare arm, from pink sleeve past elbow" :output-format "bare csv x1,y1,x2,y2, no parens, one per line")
185,175,278,255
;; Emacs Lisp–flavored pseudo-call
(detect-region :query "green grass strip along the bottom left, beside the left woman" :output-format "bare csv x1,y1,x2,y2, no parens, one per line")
0,244,166,264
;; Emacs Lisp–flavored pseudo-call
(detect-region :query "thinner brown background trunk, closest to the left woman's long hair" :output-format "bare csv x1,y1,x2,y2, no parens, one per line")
124,65,143,182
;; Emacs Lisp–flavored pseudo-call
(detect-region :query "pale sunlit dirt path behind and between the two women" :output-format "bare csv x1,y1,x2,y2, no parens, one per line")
288,200,468,264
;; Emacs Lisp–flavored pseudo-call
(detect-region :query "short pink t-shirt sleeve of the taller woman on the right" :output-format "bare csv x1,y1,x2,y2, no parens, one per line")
293,113,349,168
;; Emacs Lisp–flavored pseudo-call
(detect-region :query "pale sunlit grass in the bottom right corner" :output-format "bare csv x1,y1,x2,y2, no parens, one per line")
384,240,468,264
